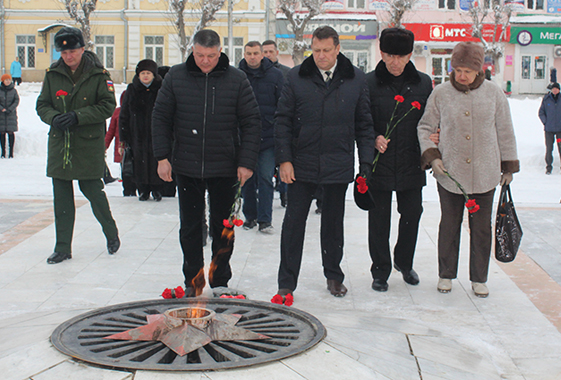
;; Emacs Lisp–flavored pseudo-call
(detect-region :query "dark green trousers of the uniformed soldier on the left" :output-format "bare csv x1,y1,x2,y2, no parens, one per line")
53,178,118,253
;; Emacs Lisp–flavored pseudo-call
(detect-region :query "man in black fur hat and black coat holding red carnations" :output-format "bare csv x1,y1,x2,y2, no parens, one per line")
367,28,432,292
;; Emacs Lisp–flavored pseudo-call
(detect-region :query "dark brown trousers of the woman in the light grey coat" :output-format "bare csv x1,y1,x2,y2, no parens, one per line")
438,184,495,282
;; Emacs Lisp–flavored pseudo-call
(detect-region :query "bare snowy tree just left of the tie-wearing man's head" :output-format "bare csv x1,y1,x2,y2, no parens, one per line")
279,0,325,65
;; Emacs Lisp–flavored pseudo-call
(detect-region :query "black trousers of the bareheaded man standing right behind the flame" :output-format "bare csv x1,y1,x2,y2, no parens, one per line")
176,174,238,288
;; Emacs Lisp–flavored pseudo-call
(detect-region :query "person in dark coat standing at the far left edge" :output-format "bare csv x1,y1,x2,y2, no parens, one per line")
0,74,19,158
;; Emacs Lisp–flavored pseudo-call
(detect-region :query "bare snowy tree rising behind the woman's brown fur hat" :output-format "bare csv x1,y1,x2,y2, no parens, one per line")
469,0,512,73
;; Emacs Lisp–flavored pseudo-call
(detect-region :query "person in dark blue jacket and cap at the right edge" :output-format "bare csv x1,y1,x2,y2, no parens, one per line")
538,82,561,174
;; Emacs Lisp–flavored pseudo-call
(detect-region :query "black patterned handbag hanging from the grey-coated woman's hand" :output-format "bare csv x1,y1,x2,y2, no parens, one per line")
495,185,522,263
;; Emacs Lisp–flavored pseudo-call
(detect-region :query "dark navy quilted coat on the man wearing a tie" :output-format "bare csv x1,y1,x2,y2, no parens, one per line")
275,54,374,184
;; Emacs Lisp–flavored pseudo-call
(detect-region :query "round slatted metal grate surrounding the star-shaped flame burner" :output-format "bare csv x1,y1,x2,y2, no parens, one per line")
51,298,326,371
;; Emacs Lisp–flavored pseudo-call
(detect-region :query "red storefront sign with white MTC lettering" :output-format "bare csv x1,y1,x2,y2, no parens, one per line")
403,23,510,42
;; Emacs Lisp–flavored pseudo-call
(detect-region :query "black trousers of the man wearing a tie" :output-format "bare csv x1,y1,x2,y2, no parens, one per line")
278,181,348,290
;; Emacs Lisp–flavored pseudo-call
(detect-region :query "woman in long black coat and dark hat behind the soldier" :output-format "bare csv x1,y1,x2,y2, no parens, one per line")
119,59,164,202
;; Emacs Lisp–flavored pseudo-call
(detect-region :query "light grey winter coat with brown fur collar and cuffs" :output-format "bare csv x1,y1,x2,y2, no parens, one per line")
417,72,520,194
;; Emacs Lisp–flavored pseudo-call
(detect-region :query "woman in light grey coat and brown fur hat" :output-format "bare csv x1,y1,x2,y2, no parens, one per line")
417,42,520,297
